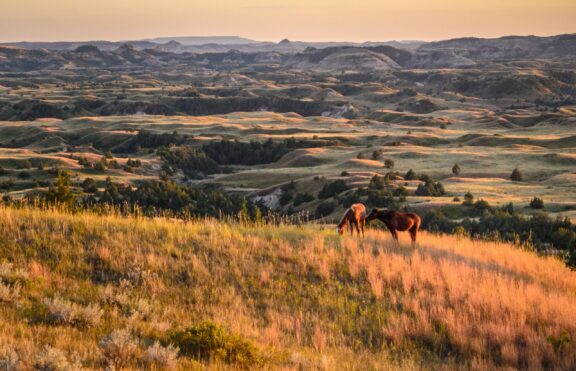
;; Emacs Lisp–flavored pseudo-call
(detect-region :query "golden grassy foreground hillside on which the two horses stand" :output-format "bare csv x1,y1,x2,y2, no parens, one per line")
0,208,576,369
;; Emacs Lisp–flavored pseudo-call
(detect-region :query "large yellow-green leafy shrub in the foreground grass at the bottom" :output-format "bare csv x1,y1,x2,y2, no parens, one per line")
170,322,262,367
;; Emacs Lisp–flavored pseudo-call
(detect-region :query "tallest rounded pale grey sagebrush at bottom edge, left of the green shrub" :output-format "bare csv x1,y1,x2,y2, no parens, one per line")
98,329,138,369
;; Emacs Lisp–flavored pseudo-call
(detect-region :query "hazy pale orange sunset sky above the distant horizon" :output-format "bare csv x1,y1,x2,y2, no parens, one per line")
0,0,576,41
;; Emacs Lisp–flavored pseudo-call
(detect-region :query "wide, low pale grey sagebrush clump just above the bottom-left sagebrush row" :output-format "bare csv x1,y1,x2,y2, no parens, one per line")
43,298,102,327
